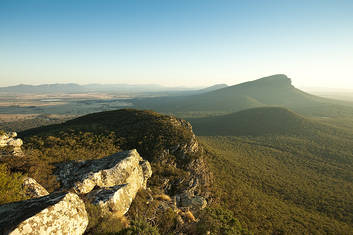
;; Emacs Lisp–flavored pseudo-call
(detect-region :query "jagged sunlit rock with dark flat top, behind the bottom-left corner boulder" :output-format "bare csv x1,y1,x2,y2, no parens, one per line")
57,150,152,216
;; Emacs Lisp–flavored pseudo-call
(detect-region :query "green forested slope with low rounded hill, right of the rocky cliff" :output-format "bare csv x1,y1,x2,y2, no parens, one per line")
193,108,353,234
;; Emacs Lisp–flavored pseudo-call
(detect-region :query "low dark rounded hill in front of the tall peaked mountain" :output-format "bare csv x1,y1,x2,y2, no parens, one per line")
189,107,320,136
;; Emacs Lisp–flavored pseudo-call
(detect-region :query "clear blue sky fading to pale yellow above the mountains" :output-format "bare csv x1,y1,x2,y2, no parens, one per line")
0,0,353,89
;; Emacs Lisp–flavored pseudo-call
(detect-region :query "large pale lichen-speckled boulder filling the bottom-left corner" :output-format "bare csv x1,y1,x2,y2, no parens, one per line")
0,192,88,235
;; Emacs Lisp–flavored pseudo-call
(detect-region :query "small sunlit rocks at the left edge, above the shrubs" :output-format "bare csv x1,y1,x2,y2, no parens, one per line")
0,132,23,157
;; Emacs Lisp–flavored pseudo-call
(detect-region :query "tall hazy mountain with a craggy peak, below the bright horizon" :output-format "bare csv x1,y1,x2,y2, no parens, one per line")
136,74,353,116
